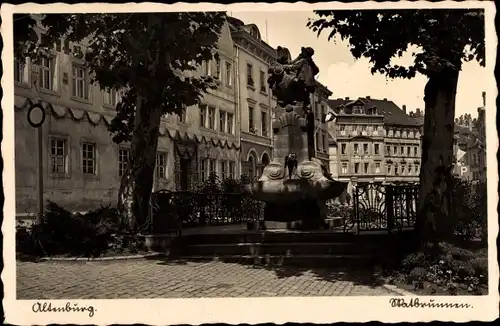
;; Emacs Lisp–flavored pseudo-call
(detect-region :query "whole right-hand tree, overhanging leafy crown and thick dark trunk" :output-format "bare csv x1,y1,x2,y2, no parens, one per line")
308,9,485,244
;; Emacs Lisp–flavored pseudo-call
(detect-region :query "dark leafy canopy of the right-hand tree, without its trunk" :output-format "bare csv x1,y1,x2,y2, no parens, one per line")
307,9,485,78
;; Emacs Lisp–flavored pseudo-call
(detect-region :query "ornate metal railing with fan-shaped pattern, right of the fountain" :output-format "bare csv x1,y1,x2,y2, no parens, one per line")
329,183,418,233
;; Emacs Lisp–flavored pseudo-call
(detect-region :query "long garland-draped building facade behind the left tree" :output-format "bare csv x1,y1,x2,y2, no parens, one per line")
14,24,240,213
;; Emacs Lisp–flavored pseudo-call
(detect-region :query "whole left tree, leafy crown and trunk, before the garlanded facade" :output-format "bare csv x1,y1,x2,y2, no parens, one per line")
14,12,225,230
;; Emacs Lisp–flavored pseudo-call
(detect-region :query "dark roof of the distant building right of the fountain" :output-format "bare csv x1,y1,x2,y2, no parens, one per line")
328,97,422,127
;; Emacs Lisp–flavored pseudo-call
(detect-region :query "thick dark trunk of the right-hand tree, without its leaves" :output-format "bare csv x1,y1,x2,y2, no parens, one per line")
416,70,459,248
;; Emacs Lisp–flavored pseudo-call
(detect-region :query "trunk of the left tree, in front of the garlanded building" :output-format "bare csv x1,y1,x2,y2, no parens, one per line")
118,97,162,232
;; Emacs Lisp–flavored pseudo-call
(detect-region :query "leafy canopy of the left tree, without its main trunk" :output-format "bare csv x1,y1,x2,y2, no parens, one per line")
14,12,225,142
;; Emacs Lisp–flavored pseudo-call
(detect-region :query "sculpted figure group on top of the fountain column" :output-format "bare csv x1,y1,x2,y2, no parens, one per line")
268,46,319,108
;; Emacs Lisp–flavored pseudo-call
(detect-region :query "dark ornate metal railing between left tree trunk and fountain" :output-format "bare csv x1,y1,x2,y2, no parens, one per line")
151,190,264,233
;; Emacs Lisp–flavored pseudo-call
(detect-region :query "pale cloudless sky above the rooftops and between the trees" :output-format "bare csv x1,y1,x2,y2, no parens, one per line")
228,11,486,117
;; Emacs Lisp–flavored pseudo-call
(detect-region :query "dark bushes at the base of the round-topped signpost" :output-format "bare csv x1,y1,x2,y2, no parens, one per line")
16,202,145,257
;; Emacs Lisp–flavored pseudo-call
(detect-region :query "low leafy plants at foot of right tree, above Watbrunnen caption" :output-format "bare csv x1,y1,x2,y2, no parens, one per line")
398,243,488,295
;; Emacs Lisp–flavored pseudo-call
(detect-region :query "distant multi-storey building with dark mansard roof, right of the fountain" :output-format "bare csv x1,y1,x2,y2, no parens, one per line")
329,96,422,192
